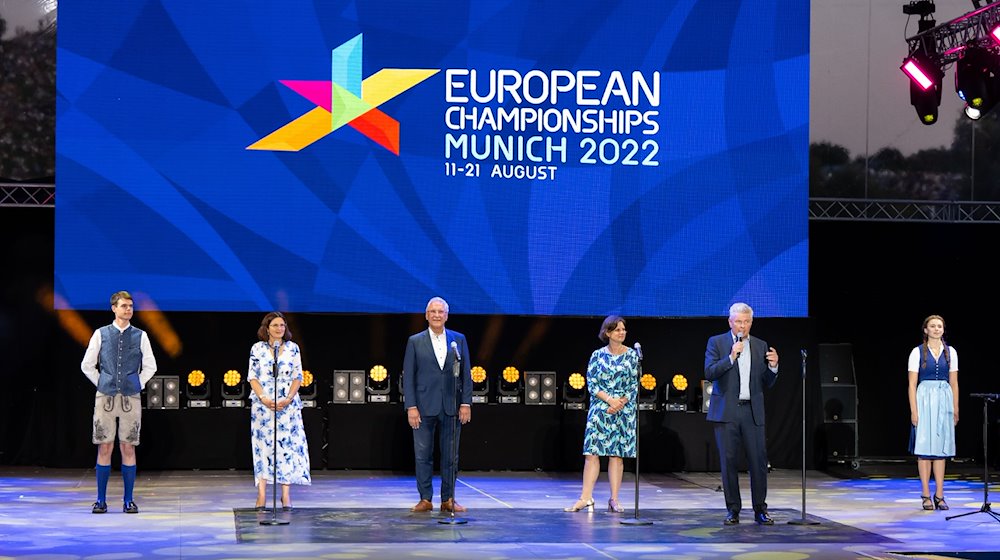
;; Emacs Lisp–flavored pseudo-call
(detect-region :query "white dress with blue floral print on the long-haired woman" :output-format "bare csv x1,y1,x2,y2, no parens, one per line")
247,341,312,485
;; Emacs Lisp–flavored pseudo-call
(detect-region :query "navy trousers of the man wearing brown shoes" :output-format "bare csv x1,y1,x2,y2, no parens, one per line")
413,412,462,502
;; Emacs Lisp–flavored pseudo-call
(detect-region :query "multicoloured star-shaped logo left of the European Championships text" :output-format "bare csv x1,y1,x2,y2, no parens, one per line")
247,34,438,156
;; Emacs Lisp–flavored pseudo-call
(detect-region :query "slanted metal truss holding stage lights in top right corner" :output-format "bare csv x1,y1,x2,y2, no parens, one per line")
906,1,1000,65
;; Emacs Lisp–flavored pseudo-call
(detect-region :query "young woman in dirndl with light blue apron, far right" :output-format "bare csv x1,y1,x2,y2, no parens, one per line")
907,315,958,510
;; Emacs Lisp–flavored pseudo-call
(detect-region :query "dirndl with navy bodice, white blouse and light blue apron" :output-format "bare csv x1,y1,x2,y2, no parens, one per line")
908,345,958,459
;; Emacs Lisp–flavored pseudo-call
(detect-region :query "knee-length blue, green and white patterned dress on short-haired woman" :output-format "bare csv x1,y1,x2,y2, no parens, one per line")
583,346,639,457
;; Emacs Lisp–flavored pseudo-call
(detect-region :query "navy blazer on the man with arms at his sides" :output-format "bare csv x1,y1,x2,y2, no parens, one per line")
403,329,472,416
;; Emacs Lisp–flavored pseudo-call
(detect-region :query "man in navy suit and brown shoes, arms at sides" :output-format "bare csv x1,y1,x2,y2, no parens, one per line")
403,297,472,512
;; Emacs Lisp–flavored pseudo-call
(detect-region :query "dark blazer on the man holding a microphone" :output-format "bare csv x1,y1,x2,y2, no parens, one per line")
705,331,778,426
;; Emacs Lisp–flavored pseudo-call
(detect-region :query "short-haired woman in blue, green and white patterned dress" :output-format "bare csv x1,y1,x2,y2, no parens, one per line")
564,315,639,513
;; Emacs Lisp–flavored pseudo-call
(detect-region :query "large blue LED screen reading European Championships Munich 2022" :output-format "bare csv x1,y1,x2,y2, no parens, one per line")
55,0,809,317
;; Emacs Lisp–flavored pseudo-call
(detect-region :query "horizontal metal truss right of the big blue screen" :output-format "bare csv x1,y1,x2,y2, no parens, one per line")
809,198,1000,224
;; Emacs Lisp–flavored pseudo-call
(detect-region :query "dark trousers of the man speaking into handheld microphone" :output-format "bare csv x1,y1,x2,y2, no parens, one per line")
715,403,767,513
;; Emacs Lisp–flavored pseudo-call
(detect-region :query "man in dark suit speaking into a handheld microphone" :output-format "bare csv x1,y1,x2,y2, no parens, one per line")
705,303,778,525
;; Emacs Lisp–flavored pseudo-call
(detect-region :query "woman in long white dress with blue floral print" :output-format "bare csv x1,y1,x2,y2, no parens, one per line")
247,311,312,511
